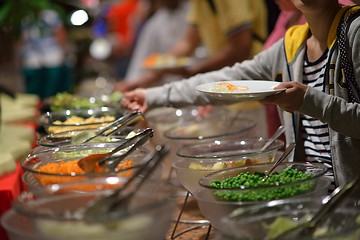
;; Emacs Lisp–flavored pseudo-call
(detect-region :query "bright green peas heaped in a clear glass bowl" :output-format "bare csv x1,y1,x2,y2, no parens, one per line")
210,168,315,201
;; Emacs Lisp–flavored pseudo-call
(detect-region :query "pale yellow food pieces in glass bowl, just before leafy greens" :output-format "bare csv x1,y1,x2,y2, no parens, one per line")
48,116,115,133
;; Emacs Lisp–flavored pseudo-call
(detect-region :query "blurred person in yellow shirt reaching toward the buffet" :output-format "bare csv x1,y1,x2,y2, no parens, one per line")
117,0,268,91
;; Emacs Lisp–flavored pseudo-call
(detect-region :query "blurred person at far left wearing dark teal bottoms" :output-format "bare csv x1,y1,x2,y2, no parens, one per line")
18,9,74,99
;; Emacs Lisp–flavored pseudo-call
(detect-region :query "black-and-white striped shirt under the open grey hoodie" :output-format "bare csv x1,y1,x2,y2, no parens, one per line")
300,50,334,188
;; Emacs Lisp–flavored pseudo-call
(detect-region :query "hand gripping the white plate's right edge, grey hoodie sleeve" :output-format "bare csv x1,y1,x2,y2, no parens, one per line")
261,82,307,112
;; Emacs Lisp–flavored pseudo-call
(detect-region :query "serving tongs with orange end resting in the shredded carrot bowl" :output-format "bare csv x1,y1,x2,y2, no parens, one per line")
78,128,154,172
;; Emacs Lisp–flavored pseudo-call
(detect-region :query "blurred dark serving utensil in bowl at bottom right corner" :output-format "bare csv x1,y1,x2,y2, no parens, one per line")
274,176,360,240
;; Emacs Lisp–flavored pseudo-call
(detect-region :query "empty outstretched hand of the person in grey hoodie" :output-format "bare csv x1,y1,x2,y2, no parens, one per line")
122,88,148,112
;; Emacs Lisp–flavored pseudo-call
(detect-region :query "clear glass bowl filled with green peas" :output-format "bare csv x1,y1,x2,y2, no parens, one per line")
193,162,331,228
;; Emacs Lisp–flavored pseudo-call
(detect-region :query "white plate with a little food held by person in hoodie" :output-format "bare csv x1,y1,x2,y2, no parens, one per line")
196,80,285,102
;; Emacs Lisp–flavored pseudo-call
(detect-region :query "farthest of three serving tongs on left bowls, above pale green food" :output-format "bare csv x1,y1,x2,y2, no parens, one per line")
71,111,145,144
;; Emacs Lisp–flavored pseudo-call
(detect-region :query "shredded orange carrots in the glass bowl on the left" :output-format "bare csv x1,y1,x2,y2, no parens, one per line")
37,159,133,185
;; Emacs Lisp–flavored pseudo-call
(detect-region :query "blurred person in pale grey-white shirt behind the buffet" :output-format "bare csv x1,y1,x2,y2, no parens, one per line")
116,0,188,91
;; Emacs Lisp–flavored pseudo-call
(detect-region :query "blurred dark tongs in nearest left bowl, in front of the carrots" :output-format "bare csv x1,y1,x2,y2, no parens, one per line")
80,143,168,222
